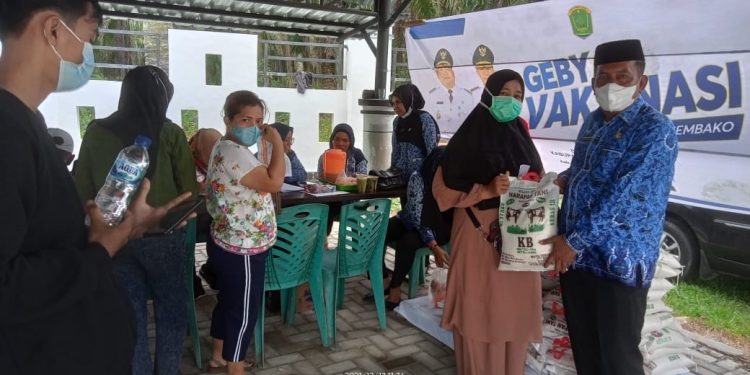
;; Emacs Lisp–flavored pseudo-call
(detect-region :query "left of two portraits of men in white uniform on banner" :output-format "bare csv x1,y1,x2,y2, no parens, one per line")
427,48,474,133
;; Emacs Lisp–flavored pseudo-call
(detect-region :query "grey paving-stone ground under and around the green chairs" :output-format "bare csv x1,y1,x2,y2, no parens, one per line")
142,230,750,375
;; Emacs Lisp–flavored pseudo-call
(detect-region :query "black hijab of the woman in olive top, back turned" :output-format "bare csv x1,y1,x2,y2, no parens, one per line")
98,65,174,177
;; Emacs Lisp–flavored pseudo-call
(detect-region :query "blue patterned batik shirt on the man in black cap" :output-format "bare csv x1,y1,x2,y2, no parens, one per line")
559,97,677,287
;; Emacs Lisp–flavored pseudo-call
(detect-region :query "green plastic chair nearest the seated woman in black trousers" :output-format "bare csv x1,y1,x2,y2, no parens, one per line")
323,199,391,342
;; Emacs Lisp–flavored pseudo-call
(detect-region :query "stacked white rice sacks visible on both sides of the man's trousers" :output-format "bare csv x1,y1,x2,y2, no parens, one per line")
526,252,695,375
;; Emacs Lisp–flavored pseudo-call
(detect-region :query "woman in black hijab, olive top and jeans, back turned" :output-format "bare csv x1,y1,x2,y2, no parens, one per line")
75,66,198,374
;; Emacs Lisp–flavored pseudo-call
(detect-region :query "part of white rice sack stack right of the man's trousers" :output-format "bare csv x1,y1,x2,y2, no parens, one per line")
639,252,696,375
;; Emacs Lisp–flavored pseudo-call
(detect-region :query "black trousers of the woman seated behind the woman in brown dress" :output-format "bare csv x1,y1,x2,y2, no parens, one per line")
383,216,448,288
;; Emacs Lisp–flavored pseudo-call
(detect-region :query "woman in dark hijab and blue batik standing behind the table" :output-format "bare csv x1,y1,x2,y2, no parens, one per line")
389,83,440,182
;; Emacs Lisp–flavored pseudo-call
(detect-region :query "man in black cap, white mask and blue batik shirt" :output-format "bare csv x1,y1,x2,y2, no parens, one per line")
542,40,677,375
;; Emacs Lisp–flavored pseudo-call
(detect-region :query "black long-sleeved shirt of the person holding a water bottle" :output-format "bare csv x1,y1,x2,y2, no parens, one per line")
0,89,135,375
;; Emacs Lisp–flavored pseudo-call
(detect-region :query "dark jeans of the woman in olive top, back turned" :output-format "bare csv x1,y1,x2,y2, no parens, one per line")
114,231,187,375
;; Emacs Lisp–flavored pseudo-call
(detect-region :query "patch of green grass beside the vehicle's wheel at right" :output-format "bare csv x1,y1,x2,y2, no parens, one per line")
666,276,750,339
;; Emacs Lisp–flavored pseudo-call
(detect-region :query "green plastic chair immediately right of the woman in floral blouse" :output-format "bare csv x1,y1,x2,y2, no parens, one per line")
255,204,330,367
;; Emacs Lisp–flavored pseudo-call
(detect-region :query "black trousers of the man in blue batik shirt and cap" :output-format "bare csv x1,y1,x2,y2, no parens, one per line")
560,270,648,375
